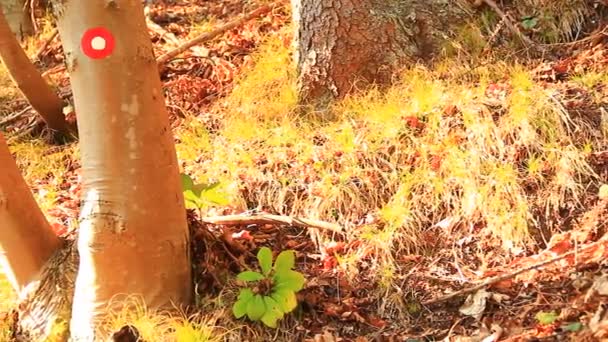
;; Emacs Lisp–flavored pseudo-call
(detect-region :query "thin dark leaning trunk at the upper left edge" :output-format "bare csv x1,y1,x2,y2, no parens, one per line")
0,6,74,135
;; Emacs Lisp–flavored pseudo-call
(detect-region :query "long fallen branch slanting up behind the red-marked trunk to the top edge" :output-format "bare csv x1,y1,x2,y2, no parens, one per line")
156,0,284,69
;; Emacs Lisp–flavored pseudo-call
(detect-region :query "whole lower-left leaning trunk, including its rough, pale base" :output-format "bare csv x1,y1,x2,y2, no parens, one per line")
0,135,77,341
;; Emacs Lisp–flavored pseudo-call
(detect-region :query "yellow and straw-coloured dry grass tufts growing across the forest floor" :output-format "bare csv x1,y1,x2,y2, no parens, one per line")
0,12,608,341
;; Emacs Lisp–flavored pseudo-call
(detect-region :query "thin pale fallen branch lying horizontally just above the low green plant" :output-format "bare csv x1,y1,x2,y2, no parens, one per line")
201,214,342,234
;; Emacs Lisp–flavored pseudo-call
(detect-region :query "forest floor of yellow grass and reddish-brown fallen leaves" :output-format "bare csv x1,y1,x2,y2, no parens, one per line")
0,0,608,342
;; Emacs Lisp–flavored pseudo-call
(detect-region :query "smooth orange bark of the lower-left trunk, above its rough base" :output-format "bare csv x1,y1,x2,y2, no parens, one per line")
0,134,59,292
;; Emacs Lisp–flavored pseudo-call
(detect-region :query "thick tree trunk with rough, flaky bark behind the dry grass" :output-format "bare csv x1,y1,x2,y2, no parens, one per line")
292,0,464,109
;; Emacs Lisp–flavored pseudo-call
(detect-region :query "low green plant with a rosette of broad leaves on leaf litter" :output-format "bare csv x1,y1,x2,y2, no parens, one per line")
232,247,305,328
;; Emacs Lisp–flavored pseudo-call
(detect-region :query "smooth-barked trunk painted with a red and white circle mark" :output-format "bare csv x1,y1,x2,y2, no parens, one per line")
54,0,192,341
